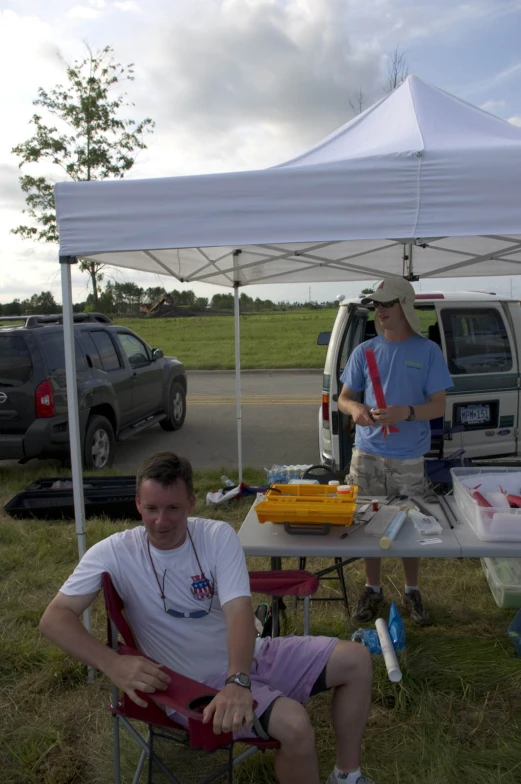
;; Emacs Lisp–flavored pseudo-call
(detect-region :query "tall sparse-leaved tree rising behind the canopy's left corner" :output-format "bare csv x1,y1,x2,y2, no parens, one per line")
12,46,154,309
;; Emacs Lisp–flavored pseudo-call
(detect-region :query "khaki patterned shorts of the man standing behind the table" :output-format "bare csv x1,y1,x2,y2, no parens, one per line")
346,449,427,496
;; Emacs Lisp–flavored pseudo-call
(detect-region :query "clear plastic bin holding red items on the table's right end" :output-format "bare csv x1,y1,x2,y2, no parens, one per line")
451,467,521,542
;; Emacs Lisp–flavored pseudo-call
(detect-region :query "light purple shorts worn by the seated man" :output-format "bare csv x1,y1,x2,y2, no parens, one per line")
201,635,338,738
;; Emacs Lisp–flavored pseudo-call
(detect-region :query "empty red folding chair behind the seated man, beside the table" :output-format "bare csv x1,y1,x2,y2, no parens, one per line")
250,569,320,637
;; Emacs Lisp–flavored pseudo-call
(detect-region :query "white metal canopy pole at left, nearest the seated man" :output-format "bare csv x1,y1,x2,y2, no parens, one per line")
60,256,92,632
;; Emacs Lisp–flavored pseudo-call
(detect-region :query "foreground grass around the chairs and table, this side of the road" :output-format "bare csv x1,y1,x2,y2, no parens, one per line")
0,464,521,784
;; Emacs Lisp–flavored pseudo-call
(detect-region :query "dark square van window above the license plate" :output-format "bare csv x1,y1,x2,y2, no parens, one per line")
441,308,512,376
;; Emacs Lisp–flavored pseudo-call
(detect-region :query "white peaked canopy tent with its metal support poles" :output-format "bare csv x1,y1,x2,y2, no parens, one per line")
55,76,521,554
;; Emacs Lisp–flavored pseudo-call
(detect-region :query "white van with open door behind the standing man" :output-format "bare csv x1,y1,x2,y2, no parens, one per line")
317,292,521,471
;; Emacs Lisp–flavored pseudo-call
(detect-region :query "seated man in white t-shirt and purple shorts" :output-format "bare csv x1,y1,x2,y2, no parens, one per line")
40,452,372,784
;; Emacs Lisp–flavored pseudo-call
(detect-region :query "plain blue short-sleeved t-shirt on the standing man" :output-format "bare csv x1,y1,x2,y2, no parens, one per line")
340,333,453,460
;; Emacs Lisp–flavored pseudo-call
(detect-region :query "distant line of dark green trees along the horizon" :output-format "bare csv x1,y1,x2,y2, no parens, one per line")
0,281,346,316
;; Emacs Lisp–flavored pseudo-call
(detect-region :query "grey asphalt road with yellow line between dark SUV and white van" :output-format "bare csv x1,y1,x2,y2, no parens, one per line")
114,370,322,478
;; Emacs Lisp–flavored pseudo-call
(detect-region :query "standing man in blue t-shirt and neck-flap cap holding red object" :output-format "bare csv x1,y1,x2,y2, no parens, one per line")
338,277,452,626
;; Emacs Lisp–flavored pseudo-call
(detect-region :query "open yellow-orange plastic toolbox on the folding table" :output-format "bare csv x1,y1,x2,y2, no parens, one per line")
255,485,358,526
